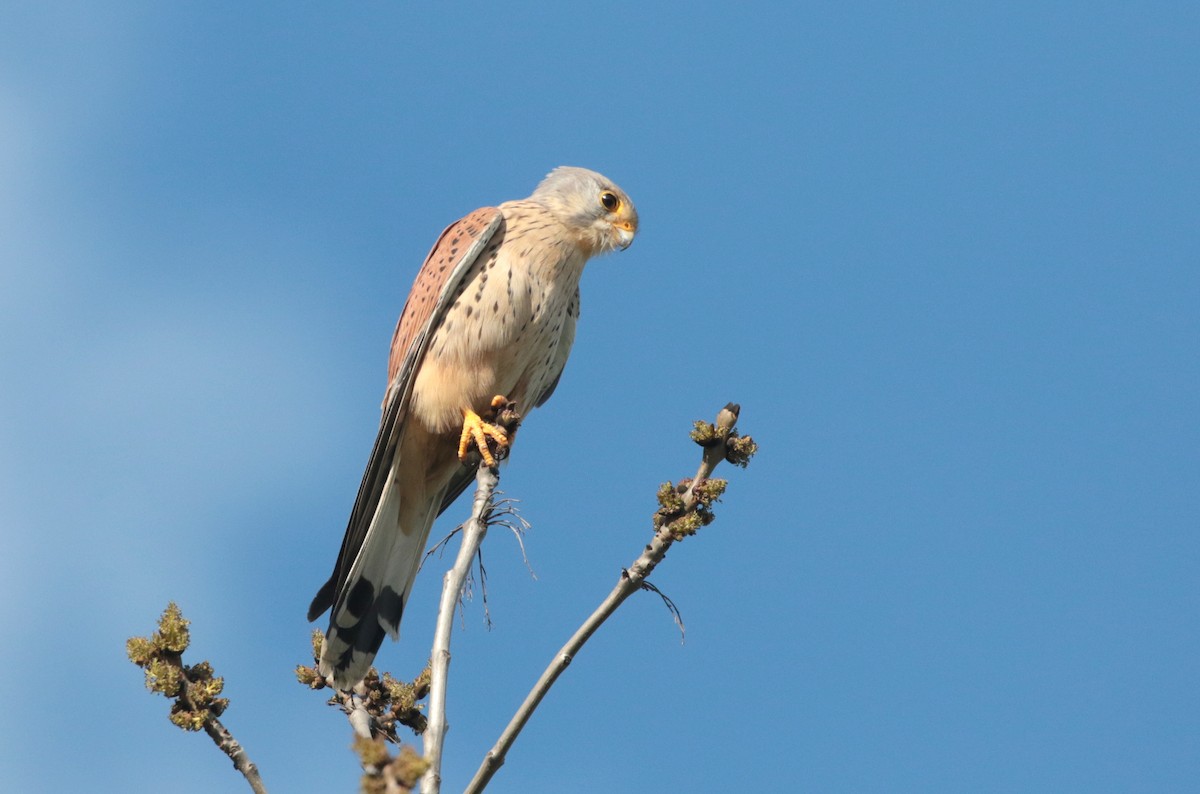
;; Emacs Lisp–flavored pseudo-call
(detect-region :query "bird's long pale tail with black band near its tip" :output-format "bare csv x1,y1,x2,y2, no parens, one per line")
318,476,442,690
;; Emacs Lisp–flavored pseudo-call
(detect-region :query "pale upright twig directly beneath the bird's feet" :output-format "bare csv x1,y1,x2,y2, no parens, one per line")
421,464,500,794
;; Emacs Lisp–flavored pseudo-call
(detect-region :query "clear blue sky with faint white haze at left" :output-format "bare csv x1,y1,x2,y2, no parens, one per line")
0,2,1200,793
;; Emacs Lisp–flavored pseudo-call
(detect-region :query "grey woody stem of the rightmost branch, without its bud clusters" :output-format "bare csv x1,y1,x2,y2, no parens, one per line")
464,403,738,794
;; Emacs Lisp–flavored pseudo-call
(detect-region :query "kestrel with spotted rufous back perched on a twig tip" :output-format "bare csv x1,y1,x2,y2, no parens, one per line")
308,166,638,690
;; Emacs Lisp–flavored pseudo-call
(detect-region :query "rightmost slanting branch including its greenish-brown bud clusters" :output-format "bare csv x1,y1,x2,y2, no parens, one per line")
466,403,757,794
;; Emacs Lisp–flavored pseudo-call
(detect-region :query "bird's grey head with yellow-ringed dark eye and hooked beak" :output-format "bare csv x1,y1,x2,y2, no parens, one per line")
530,166,637,255
